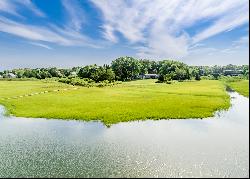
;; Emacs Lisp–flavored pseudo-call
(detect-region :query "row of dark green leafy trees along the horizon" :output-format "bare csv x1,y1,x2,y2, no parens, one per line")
0,57,249,83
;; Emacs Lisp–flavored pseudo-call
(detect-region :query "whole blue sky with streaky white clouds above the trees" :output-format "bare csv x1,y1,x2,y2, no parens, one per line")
0,0,249,70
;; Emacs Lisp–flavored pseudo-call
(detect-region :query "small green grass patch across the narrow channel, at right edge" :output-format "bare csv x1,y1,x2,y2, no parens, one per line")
228,80,249,97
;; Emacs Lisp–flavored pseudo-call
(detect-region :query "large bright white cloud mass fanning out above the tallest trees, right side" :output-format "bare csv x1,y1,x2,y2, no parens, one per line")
92,0,249,58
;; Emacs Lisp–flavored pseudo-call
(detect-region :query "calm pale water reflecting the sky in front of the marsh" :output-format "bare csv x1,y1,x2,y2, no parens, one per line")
0,92,249,177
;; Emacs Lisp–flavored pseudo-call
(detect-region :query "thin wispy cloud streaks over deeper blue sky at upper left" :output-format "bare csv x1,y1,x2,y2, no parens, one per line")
0,0,99,48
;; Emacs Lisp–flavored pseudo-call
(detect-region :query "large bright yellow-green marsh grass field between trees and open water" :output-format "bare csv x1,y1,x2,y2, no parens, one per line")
0,80,230,125
